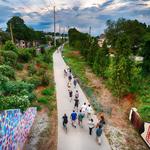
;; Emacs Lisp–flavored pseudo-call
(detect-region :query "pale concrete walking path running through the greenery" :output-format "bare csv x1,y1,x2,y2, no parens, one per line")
53,48,111,150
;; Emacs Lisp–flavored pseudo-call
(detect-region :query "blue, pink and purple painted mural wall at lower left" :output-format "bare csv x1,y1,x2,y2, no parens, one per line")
0,108,37,150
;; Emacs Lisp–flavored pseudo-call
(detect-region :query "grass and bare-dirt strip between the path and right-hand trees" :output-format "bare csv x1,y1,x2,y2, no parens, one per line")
63,44,148,150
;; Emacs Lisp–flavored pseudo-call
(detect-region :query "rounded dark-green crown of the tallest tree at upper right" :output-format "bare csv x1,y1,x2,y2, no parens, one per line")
105,18,147,54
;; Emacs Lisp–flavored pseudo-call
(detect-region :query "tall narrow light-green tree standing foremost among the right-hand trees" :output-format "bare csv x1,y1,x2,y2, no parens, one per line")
112,33,132,99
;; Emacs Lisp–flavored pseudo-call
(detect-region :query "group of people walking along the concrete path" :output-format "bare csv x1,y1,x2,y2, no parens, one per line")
62,68,105,144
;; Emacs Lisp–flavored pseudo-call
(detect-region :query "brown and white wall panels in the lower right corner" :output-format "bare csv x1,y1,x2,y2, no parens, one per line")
129,108,150,147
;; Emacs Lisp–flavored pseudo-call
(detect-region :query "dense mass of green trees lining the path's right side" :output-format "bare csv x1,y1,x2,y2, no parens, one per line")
67,19,150,121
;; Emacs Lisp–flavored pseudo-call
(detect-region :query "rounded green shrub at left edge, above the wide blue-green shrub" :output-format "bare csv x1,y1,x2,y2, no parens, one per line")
0,65,15,79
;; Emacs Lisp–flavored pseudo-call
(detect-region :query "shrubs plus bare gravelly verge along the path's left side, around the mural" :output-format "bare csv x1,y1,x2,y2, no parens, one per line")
0,41,57,150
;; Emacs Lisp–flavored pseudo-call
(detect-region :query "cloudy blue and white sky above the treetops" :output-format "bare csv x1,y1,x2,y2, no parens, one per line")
0,0,150,35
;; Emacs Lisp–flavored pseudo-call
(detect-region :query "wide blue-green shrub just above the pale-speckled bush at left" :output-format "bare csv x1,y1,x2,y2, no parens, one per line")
4,81,34,95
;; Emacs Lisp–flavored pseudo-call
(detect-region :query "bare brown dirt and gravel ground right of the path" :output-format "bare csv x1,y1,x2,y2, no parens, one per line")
86,69,148,150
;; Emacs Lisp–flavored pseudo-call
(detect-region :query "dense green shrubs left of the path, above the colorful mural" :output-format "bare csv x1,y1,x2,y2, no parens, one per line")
0,41,55,111
